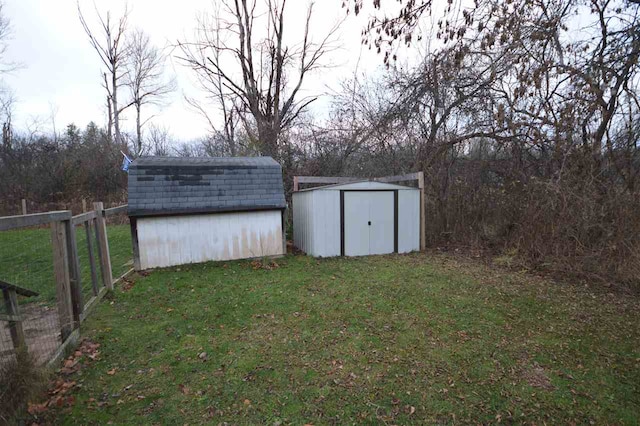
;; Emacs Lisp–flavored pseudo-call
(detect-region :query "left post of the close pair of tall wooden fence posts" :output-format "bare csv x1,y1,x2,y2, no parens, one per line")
51,221,73,342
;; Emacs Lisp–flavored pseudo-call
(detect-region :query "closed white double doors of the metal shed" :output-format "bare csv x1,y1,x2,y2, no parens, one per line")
343,191,396,256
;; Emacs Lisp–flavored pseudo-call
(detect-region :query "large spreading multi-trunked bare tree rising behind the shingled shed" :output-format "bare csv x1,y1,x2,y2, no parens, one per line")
179,0,337,156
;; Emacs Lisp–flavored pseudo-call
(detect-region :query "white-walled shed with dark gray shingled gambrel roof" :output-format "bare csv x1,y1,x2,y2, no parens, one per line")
128,157,286,269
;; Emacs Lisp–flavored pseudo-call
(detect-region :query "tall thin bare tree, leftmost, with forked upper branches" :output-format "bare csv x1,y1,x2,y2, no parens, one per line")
77,2,131,145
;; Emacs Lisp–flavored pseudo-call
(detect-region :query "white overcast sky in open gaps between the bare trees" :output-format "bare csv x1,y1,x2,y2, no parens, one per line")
4,0,390,140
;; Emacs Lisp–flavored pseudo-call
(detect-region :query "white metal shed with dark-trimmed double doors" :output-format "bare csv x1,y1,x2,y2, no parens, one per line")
293,181,420,257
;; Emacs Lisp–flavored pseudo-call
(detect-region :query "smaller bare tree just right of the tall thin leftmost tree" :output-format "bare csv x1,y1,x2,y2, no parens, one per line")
125,30,176,154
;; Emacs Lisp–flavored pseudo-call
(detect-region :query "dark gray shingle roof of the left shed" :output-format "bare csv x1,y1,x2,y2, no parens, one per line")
129,157,286,216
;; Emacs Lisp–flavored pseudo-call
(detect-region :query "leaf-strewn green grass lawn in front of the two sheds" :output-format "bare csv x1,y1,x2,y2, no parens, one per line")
46,255,640,425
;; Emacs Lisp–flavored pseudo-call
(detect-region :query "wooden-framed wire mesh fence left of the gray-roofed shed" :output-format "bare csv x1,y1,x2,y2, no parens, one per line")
0,203,133,364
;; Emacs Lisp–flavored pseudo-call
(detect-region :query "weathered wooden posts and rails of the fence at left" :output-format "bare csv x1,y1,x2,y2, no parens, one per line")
0,202,133,365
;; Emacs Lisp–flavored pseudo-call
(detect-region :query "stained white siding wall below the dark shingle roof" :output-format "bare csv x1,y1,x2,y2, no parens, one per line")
138,210,284,269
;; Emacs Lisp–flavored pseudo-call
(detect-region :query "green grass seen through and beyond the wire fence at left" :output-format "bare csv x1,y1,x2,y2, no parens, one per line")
0,225,132,304
